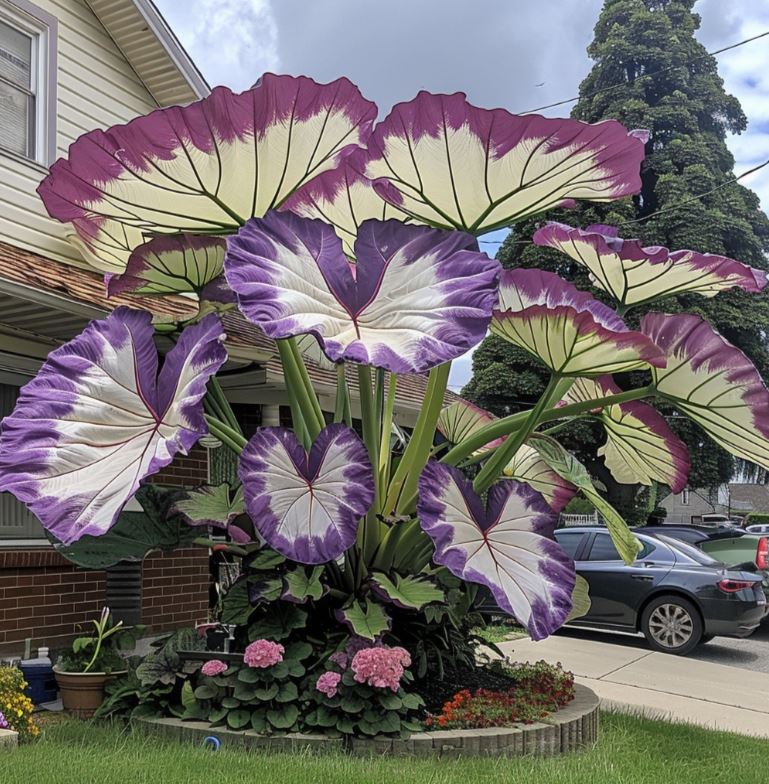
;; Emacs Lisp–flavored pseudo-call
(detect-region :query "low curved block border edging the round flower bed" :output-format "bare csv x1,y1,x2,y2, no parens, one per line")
132,684,599,757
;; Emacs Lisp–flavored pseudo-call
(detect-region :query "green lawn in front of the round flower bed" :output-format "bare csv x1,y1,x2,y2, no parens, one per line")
0,714,769,784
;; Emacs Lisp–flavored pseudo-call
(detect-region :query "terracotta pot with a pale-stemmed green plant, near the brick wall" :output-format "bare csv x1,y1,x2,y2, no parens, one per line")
53,607,128,718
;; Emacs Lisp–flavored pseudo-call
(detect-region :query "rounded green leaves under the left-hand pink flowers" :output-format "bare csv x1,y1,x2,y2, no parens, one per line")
187,642,312,734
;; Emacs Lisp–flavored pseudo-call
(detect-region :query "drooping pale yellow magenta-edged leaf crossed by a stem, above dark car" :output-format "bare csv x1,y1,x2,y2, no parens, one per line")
564,376,690,493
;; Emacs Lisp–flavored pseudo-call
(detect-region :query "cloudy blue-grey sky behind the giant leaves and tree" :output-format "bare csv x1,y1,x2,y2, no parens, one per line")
156,0,769,389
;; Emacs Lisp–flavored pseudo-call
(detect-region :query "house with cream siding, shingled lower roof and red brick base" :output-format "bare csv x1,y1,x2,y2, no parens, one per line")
0,0,448,655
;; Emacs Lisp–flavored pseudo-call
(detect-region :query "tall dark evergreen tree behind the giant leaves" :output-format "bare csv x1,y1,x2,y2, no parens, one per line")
463,0,769,519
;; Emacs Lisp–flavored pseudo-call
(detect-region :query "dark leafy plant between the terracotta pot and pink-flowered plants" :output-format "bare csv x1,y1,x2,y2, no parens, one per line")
96,629,204,717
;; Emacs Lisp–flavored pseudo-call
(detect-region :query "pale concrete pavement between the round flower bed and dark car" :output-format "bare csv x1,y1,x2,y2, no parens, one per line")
499,636,769,738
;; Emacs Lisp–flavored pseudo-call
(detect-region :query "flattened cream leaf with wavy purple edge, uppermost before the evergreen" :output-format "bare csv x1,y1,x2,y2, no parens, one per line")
533,223,767,306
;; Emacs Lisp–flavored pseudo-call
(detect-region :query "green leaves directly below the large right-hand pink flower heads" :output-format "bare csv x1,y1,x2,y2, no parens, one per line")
304,669,424,737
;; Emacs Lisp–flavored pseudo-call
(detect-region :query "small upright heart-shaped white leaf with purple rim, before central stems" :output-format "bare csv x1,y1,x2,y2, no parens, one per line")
238,424,374,564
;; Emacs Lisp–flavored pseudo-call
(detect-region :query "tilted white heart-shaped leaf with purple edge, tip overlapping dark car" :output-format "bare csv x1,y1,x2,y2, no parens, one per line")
417,460,575,640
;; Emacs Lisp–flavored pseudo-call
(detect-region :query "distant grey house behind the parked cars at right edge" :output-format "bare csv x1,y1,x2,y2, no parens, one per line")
660,482,769,523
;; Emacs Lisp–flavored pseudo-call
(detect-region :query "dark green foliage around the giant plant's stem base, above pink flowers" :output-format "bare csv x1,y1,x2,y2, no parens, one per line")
221,547,483,677
